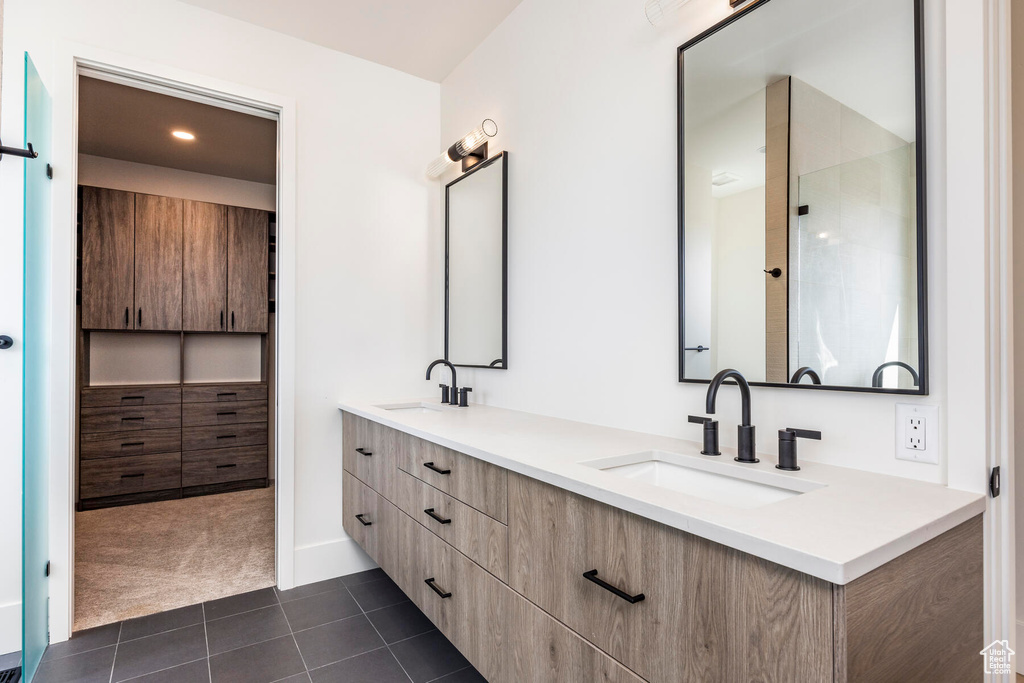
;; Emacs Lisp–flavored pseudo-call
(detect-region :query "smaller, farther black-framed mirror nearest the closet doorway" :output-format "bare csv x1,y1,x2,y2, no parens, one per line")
444,152,508,370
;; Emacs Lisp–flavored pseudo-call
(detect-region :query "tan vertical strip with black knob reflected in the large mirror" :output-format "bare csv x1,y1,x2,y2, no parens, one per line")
765,77,791,384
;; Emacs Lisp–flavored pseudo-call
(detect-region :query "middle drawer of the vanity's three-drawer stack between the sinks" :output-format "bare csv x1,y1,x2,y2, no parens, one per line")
395,472,509,581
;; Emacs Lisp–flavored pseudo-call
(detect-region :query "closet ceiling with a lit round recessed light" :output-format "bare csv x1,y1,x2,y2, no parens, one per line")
78,77,278,184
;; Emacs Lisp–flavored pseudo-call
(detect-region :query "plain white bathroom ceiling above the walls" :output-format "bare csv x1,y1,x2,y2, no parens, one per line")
177,0,521,83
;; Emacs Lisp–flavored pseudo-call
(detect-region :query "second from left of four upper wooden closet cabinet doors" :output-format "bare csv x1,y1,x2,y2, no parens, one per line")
135,195,182,332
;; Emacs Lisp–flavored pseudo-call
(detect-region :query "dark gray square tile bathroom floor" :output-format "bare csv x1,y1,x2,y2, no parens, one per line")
20,569,485,683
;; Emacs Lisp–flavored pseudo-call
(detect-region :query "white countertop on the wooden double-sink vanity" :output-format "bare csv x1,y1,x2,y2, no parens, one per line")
339,399,985,585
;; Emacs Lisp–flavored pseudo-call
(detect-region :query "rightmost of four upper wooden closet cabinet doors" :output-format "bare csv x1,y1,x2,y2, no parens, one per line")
227,207,270,333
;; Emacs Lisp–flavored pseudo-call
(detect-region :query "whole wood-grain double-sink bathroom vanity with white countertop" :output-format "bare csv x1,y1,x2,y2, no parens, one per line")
340,401,985,683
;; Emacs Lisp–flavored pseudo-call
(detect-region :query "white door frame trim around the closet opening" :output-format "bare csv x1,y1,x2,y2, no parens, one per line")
49,41,297,642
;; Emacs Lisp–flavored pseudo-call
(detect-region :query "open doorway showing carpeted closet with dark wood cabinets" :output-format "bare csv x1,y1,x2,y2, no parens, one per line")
73,70,278,631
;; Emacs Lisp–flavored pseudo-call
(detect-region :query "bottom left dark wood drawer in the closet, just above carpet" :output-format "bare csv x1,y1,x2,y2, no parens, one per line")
79,453,181,499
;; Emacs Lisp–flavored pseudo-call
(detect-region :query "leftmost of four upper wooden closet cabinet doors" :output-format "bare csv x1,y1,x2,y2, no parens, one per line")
82,187,135,330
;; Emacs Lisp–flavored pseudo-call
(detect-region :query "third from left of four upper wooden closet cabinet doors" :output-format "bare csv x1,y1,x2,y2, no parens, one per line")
181,202,227,332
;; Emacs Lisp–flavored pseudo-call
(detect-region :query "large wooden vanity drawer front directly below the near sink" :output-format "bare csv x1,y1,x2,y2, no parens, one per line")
509,474,833,683
